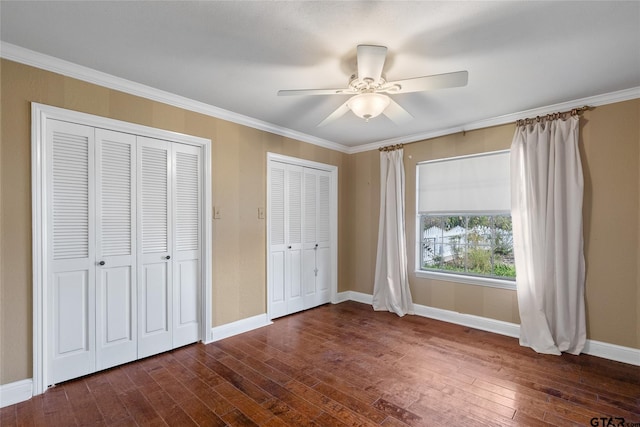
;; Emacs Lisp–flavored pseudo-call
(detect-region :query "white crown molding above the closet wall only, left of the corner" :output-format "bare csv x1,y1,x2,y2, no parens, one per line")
0,42,348,153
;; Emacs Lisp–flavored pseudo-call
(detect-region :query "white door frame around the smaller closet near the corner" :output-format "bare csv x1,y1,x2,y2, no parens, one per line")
265,153,339,320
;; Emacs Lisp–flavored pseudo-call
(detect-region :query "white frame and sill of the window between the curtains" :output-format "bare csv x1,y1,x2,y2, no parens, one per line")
414,150,517,290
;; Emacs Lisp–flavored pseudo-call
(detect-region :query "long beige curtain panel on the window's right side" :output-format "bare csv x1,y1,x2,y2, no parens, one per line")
511,115,586,354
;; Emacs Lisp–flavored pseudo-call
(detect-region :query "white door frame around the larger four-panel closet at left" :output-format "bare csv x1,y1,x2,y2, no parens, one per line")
31,102,213,395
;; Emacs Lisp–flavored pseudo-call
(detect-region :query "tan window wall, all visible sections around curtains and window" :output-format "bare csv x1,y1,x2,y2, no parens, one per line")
349,100,640,348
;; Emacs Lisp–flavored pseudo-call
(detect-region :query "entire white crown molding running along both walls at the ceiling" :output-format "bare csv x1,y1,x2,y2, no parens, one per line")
0,42,640,154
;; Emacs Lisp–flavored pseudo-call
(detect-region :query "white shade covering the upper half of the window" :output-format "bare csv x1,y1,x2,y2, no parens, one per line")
418,151,511,214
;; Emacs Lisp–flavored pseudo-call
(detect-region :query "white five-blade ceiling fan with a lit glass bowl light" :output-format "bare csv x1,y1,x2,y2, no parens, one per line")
278,45,469,126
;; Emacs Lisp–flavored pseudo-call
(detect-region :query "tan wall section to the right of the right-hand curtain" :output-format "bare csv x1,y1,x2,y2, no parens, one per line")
580,99,640,348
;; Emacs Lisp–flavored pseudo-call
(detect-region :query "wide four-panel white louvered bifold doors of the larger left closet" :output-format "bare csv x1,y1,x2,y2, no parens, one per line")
47,120,202,384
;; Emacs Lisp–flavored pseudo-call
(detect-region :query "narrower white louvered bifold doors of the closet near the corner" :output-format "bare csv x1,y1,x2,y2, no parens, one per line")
268,161,331,318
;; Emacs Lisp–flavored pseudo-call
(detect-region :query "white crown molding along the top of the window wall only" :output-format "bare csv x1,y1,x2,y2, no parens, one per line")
347,86,640,154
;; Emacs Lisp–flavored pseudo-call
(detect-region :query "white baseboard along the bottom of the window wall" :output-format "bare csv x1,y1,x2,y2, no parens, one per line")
340,291,640,366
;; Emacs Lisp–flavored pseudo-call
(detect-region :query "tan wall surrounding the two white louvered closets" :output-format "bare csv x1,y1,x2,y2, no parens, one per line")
0,60,350,384
